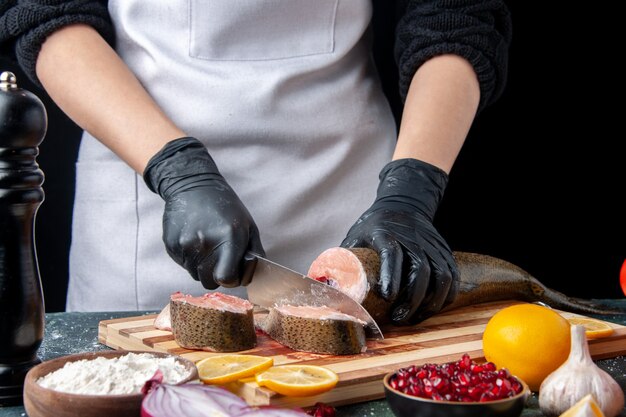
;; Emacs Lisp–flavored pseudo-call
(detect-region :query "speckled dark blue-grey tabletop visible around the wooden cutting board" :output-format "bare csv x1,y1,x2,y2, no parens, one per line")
0,299,626,417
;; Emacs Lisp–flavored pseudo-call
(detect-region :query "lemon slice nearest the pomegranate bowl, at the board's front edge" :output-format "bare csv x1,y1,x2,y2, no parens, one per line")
256,365,339,397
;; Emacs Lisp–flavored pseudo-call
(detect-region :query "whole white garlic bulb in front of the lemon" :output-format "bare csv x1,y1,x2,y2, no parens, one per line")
539,326,624,417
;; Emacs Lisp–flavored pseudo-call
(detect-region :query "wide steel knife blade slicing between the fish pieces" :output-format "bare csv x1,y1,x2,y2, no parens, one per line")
246,254,384,339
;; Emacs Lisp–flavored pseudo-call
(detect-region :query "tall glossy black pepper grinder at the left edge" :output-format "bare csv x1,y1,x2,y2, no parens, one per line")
0,72,48,406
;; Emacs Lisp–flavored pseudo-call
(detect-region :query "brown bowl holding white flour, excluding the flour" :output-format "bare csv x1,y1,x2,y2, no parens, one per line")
24,350,198,417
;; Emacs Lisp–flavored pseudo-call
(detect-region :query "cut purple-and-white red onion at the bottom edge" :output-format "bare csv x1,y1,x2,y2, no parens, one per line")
141,383,309,417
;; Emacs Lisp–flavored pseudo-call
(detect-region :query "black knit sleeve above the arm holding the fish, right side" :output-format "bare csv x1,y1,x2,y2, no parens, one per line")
394,0,511,110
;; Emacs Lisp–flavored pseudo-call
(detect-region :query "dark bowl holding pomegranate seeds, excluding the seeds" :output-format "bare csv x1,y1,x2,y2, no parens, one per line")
383,372,530,417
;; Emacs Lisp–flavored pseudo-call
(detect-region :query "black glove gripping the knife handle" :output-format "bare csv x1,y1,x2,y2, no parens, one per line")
143,138,265,289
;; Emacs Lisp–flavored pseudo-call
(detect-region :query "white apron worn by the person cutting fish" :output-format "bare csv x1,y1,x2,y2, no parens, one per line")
67,0,396,311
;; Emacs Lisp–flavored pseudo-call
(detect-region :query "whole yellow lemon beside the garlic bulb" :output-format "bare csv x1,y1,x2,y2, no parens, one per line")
483,304,570,391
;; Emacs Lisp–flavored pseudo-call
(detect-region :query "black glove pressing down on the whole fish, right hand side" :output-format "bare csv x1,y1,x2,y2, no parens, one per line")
341,159,458,324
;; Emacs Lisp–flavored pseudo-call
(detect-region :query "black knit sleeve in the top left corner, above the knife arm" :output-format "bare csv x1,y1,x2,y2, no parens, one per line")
0,0,114,85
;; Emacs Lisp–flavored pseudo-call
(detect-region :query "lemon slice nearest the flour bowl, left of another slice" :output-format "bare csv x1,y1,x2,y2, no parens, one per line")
196,355,274,385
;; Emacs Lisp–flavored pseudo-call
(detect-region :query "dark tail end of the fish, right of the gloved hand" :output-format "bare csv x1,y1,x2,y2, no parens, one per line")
441,252,626,315
